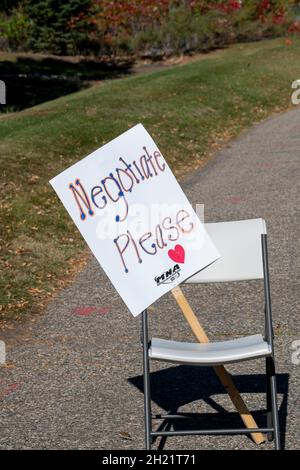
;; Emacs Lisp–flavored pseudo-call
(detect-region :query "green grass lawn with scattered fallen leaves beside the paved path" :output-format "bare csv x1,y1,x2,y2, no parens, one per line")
0,39,300,324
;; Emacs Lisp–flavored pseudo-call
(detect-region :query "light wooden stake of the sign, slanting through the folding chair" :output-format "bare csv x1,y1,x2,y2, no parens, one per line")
171,286,265,444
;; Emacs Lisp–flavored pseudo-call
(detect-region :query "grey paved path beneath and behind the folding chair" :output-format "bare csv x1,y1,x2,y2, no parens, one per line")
0,108,300,449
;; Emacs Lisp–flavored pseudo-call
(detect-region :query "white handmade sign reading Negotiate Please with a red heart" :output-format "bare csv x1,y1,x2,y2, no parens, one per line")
50,124,219,316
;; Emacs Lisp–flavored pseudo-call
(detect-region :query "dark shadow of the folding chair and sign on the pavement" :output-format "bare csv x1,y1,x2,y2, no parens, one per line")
128,366,289,449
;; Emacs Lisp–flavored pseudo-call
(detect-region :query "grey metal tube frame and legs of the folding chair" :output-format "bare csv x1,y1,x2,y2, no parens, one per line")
141,234,280,450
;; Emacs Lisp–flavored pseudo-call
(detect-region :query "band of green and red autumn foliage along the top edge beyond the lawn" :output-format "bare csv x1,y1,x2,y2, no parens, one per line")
0,0,297,54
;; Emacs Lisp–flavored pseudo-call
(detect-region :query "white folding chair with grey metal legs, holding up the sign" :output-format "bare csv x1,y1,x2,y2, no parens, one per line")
142,219,280,449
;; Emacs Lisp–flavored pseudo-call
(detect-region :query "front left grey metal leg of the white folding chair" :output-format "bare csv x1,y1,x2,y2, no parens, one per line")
142,310,152,450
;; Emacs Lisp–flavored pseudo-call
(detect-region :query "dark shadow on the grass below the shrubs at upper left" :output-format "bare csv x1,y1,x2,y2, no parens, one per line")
0,56,133,112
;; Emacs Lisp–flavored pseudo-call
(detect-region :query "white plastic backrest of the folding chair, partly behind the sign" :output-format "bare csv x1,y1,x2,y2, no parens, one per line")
185,219,266,283
